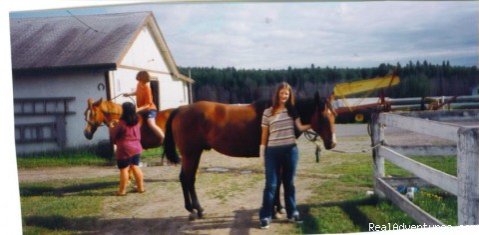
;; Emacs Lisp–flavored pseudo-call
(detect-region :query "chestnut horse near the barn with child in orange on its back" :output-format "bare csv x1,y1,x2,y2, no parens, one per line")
83,98,173,149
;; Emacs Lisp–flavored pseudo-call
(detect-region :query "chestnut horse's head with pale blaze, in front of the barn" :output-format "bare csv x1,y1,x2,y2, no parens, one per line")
83,98,121,140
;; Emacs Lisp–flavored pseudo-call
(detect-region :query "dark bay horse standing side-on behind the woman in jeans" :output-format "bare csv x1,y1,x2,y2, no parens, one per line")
164,94,336,218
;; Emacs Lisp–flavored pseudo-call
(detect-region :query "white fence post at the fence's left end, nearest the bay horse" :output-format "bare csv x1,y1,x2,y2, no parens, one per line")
370,113,385,197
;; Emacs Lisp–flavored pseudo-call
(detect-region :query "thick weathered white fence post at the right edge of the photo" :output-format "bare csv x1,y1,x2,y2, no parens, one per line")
457,127,479,225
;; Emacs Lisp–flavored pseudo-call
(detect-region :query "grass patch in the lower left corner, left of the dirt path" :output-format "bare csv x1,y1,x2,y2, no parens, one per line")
20,177,118,234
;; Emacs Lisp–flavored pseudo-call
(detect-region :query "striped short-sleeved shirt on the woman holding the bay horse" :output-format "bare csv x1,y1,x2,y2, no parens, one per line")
261,107,296,147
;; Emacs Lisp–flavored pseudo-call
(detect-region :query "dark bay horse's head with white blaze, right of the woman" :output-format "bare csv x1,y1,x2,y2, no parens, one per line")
311,93,336,149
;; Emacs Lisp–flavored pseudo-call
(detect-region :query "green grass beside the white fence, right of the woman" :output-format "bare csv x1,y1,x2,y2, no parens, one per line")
297,152,457,234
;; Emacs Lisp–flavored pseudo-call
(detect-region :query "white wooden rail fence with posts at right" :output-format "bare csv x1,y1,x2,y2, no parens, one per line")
371,110,479,225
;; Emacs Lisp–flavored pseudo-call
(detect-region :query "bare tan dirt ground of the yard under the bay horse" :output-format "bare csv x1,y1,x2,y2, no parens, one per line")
19,124,458,234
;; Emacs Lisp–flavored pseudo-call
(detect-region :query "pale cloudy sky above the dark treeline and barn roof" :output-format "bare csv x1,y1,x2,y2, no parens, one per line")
6,1,479,69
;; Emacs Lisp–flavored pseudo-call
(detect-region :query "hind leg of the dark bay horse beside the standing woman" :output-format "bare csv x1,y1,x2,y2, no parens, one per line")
181,151,204,219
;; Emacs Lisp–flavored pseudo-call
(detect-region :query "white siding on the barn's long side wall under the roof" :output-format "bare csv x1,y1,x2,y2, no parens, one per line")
13,71,108,153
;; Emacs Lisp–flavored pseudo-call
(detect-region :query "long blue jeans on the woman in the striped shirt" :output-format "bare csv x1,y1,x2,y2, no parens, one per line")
259,145,298,219
